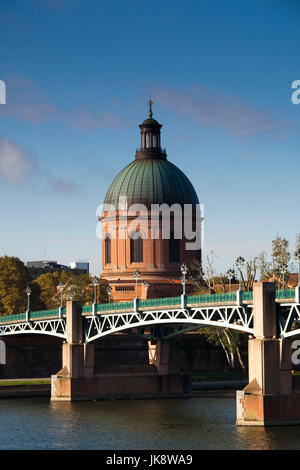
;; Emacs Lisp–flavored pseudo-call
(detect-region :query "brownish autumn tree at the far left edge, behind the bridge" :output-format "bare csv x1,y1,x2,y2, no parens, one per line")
0,256,29,315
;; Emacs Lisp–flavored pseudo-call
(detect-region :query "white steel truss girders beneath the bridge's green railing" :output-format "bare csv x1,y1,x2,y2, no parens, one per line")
0,303,300,342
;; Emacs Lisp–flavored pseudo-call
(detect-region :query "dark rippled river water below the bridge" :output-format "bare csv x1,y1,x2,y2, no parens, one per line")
0,394,300,450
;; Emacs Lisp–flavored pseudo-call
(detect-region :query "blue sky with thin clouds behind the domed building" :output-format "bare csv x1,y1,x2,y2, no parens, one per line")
0,0,300,274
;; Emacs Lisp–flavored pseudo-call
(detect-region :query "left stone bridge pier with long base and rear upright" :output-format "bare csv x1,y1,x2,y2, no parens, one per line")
51,302,191,401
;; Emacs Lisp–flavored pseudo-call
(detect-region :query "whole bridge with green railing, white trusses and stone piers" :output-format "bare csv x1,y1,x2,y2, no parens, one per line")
0,282,300,425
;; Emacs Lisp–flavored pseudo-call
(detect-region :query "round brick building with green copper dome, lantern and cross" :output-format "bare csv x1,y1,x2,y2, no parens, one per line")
99,101,201,302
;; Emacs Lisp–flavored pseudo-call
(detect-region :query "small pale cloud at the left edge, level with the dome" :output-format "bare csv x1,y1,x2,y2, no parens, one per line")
0,139,36,184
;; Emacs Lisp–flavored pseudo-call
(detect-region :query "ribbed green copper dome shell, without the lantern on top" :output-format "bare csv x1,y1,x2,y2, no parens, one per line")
104,158,199,208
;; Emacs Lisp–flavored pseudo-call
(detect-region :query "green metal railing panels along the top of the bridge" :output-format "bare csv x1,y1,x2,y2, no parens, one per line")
0,289,295,324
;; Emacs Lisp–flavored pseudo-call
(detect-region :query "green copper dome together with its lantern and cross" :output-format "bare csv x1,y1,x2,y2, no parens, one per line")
104,105,199,209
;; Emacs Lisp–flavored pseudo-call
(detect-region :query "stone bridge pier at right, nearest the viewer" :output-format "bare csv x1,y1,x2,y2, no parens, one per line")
236,282,300,426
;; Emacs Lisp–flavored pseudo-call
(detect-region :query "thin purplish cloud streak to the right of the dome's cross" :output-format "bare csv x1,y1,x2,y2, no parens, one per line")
155,86,288,137
